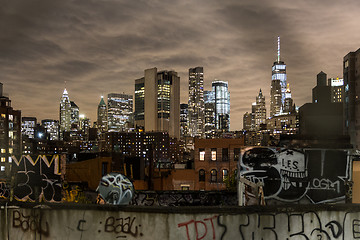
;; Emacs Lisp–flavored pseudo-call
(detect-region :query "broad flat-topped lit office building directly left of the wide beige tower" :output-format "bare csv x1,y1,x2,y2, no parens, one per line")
107,93,133,132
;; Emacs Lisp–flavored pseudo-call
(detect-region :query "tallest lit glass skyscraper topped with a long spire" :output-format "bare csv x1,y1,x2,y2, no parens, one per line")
270,37,286,117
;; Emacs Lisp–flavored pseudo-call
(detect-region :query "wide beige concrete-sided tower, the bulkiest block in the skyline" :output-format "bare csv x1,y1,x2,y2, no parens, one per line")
135,68,180,139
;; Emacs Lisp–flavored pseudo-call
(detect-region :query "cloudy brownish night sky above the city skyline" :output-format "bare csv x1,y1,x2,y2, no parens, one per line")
0,0,360,130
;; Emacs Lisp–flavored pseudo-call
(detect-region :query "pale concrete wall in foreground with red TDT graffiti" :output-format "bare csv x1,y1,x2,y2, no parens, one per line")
0,204,360,240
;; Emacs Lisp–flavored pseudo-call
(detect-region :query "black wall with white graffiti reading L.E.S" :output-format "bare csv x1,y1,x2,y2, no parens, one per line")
239,147,351,203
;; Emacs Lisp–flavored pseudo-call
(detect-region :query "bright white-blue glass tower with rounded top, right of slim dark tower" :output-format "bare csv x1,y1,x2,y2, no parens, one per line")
212,80,230,132
